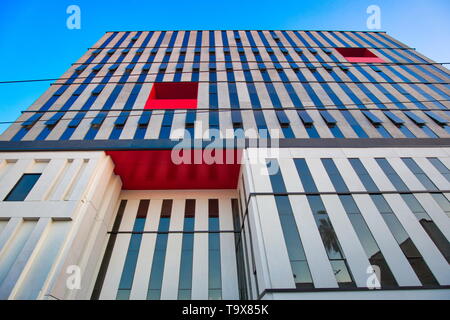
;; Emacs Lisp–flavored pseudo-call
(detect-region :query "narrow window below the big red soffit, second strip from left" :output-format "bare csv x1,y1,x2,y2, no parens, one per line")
116,200,150,300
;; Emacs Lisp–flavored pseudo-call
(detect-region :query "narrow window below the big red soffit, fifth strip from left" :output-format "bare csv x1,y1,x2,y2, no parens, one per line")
208,199,222,300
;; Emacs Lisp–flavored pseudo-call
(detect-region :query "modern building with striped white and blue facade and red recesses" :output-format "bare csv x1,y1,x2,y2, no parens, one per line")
0,30,450,300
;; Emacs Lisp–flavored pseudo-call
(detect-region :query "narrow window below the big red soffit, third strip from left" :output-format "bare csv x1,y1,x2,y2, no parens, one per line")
147,200,172,300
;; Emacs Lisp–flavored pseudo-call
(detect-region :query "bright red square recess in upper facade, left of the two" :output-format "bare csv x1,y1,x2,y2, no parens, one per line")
144,82,198,109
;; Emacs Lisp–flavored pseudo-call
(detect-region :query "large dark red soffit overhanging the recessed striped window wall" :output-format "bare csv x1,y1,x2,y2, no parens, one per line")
106,149,242,190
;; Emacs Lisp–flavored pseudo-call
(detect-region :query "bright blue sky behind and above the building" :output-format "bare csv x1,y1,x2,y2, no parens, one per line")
0,0,450,133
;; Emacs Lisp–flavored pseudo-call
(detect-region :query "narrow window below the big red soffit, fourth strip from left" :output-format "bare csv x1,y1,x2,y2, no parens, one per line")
178,199,195,300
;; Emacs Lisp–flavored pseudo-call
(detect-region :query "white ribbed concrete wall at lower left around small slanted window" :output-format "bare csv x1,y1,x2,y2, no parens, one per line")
0,152,121,299
